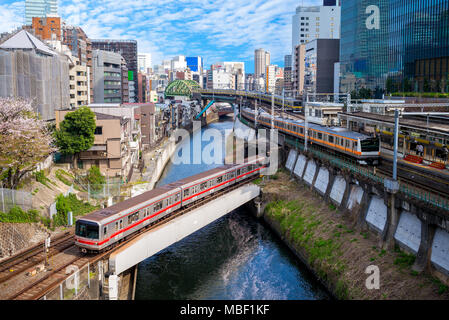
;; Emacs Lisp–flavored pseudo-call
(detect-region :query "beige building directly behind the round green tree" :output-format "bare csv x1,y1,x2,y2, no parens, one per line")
56,110,133,182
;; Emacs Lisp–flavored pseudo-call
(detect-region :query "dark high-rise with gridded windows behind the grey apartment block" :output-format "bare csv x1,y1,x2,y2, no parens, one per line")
92,39,138,103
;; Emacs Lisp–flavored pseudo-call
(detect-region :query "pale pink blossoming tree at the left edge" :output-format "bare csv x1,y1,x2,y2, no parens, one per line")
0,98,56,189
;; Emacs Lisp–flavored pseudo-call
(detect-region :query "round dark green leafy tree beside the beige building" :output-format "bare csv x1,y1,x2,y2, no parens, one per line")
55,107,97,163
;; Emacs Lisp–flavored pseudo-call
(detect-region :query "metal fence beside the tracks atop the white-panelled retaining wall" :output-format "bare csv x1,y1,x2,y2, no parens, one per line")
285,137,449,210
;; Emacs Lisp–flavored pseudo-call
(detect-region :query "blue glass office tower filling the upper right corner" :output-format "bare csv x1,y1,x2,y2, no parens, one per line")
340,0,449,93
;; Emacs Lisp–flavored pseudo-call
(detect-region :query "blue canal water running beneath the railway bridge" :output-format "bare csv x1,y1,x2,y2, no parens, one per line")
135,121,329,300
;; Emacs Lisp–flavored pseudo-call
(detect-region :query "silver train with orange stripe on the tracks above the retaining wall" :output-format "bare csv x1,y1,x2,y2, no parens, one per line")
241,108,381,166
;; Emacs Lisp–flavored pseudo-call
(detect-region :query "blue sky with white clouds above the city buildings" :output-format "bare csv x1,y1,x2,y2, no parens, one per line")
0,0,322,73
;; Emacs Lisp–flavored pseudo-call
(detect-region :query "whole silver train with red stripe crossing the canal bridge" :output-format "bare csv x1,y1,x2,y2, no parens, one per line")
75,156,269,253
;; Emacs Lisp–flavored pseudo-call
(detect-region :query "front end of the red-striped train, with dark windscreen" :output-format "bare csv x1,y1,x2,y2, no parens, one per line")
75,219,101,253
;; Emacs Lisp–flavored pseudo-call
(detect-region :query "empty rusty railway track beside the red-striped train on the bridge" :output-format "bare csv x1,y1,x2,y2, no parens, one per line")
7,176,259,300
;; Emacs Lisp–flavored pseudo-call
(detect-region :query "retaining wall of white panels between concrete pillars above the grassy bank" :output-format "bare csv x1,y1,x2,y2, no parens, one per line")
285,149,449,284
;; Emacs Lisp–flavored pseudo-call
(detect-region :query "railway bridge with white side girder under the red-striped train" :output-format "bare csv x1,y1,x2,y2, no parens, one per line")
0,180,260,300
